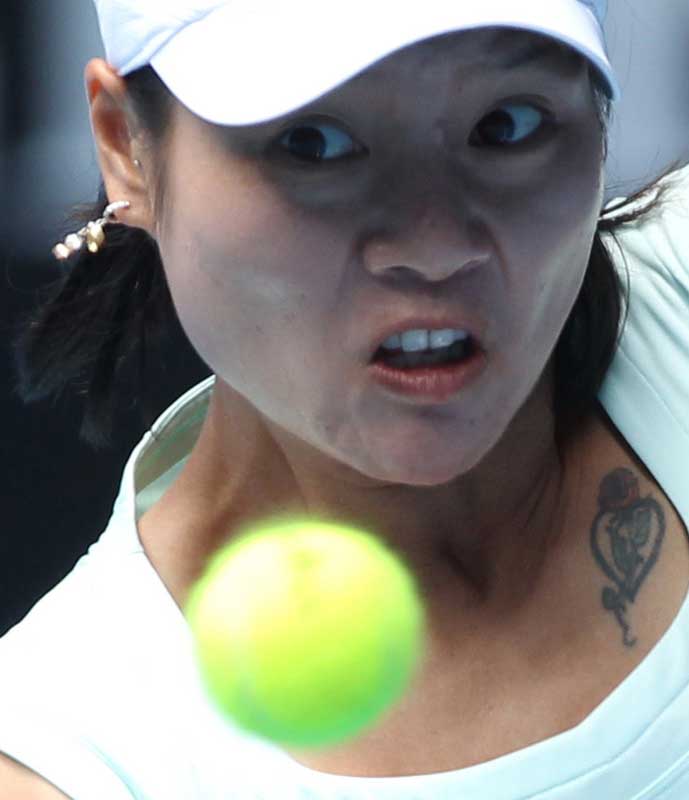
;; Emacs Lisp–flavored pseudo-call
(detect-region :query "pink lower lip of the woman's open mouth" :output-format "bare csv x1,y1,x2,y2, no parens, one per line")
368,350,487,403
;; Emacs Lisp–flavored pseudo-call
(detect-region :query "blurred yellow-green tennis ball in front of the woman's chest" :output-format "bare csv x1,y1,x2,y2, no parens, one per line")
185,519,425,748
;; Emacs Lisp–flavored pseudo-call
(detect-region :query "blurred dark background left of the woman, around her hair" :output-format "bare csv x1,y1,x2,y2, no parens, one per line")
0,0,209,635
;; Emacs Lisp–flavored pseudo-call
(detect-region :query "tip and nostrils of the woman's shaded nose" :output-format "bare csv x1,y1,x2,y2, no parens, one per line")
363,195,491,282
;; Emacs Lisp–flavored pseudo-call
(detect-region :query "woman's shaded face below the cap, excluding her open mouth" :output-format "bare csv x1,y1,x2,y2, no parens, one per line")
157,29,603,485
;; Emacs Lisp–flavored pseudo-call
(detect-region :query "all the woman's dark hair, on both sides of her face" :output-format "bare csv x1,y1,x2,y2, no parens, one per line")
17,61,681,456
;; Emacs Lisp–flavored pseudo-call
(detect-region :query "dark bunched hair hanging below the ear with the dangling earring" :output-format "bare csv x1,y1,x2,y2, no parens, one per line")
16,179,176,446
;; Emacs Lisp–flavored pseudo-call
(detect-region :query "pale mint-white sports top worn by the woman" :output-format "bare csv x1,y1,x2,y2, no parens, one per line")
0,161,689,800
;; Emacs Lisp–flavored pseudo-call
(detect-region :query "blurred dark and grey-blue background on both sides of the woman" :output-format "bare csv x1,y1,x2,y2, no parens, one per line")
0,0,689,635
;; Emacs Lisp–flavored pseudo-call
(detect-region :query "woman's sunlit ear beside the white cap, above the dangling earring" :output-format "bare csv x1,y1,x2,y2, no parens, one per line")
84,58,155,238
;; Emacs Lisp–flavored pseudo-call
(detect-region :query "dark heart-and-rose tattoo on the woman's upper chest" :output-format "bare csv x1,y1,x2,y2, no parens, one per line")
591,468,665,647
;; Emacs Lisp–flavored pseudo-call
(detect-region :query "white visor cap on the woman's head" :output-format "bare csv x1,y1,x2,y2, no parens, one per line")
94,0,621,125
